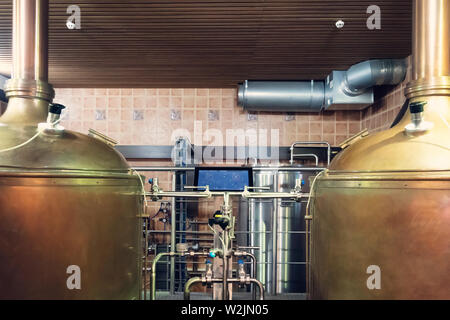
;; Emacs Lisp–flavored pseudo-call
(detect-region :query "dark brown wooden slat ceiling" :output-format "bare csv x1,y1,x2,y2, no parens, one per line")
0,0,412,87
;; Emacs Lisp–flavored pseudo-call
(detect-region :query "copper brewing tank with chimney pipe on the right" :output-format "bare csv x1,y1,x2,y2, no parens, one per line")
308,0,450,299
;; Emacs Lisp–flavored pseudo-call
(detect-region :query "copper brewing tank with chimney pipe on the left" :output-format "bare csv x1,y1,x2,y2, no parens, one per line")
0,0,142,299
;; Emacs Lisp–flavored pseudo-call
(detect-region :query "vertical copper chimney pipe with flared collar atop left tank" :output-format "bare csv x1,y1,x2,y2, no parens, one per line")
2,0,55,125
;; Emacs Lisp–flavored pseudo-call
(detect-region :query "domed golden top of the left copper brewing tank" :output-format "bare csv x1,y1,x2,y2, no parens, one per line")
0,123,130,175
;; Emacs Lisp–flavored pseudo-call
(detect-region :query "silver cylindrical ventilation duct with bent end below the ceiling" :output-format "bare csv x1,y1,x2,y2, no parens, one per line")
238,59,407,112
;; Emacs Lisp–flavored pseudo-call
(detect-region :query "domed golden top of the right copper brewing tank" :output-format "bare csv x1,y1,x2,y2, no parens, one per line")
329,96,450,174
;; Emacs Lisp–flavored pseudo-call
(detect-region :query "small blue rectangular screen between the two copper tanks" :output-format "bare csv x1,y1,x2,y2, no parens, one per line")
195,167,253,191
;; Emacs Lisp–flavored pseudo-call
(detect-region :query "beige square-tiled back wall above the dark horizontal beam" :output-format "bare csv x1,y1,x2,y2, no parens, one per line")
55,89,361,146
